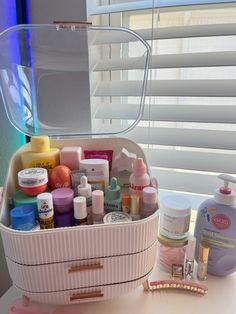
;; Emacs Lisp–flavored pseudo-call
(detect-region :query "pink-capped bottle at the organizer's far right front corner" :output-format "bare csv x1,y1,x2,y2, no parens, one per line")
141,186,158,219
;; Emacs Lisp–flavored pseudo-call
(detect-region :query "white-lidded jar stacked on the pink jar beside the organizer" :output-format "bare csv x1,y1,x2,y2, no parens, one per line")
159,195,191,239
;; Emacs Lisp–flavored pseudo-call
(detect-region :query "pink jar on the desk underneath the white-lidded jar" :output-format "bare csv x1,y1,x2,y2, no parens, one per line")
157,235,188,272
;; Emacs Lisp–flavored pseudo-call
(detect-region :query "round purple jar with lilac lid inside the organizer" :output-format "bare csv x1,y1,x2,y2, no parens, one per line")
52,188,74,214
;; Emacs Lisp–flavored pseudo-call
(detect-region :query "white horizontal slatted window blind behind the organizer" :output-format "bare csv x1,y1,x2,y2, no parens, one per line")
89,0,236,194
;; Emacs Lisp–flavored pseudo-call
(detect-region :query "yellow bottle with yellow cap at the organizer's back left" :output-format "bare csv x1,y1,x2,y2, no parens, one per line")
21,136,60,170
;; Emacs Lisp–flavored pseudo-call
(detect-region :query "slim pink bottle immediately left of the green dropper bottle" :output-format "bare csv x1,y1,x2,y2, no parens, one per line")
92,190,105,224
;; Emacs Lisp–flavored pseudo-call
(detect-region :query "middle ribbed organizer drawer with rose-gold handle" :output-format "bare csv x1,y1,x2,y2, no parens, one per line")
7,242,156,292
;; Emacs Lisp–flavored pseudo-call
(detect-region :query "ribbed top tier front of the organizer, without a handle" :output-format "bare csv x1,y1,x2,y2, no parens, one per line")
1,213,158,265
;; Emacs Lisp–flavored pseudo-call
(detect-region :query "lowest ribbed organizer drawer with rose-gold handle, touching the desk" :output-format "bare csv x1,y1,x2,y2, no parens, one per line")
17,269,152,304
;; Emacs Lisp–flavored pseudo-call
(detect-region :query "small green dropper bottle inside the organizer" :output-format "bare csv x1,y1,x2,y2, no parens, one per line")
105,177,121,213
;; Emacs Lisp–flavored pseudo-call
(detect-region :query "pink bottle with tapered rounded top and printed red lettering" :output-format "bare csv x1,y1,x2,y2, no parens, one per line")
129,158,150,197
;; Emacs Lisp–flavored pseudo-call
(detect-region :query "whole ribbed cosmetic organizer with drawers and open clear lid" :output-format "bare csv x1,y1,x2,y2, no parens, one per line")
0,25,158,304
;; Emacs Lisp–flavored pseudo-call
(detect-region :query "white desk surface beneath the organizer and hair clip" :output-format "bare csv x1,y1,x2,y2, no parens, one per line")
0,262,236,314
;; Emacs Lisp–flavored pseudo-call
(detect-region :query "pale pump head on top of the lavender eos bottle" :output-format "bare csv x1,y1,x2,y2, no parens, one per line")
214,174,236,205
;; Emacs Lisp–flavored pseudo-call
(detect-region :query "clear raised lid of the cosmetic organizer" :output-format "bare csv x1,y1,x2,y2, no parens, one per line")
0,24,150,137
